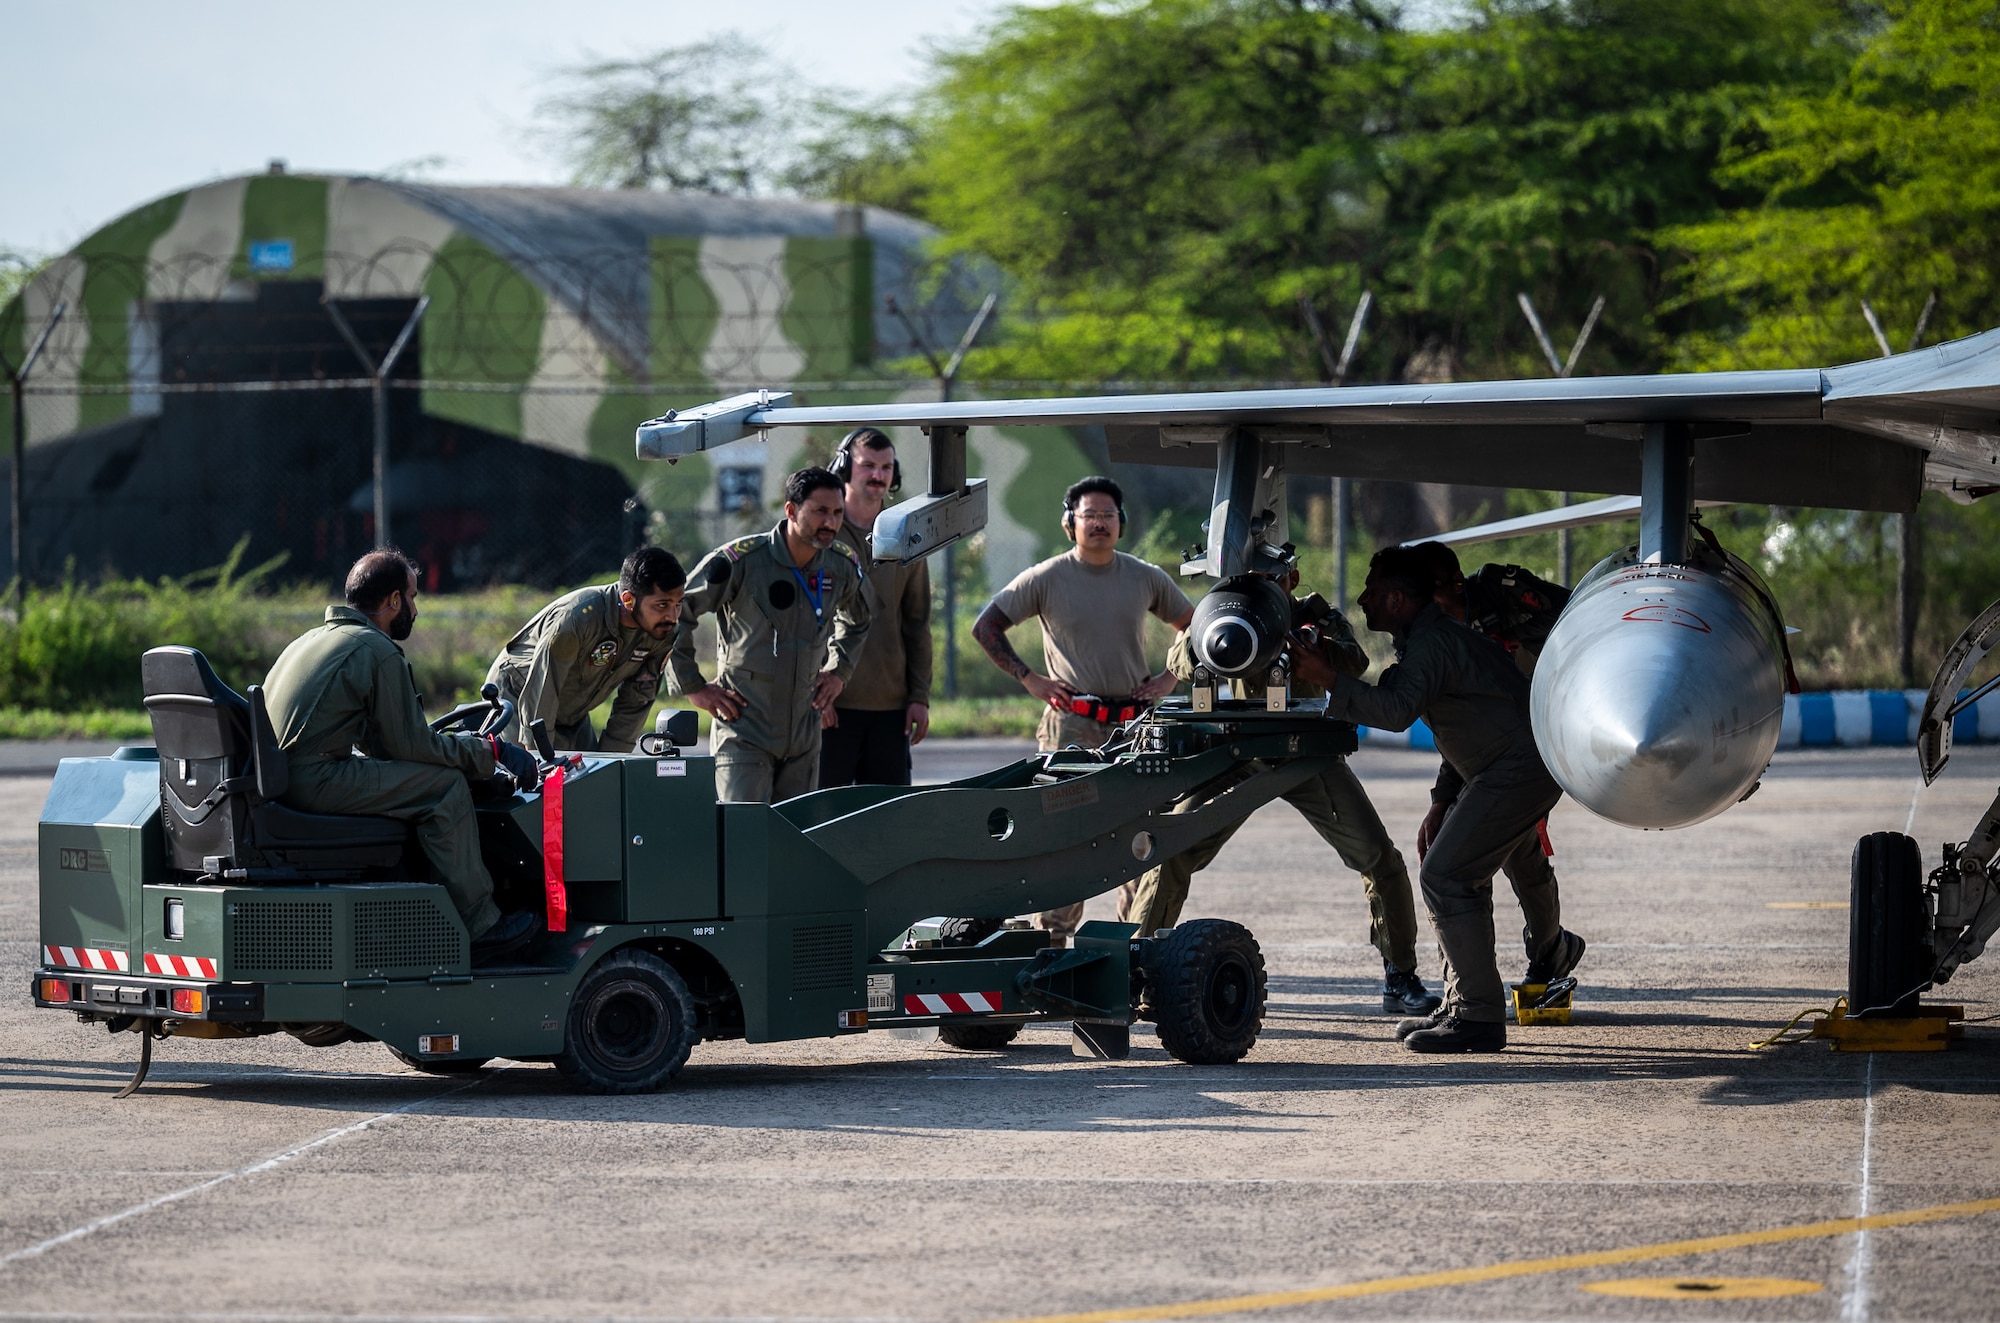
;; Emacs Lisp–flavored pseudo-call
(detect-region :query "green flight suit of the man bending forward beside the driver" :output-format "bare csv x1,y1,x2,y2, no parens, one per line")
486,584,674,753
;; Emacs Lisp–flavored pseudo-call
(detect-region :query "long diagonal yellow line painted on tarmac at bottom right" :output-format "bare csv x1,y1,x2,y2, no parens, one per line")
984,1199,2000,1323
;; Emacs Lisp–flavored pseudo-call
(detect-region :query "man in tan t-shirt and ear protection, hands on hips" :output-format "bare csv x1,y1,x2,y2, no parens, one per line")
972,478,1194,937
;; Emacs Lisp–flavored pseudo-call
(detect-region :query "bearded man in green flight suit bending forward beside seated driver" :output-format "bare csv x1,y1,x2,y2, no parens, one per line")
486,548,688,753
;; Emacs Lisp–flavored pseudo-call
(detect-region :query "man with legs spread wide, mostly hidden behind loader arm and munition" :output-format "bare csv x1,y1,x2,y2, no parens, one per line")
1128,570,1440,1015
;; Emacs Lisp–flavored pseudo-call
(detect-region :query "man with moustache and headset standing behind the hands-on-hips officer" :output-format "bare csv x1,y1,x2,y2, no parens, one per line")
820,428,930,787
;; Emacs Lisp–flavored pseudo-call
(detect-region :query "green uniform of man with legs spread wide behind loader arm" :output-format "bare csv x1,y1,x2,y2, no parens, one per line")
1128,612,1416,973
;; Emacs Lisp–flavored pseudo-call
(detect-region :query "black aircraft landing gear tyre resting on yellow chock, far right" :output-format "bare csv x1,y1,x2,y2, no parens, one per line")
1848,831,1936,1015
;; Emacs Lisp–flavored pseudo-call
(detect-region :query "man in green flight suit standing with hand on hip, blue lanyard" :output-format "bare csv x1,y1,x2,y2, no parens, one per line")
670,477,868,803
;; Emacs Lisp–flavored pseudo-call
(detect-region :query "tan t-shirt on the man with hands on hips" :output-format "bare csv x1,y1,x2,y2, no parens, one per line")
992,550,1194,697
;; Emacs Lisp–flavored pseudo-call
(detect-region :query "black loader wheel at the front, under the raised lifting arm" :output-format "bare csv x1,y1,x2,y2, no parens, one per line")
1146,919,1264,1065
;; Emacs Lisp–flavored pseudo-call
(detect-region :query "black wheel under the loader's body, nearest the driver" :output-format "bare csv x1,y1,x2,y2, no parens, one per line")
556,949,700,1093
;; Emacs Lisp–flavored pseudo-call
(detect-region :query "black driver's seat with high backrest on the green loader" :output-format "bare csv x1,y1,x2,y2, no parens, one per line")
140,648,408,879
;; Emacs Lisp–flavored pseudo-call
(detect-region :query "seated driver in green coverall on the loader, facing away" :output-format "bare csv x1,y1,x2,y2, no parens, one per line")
264,548,540,963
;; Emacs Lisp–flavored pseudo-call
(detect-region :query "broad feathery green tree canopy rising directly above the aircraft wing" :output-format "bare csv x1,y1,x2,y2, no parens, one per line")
914,0,1856,380
